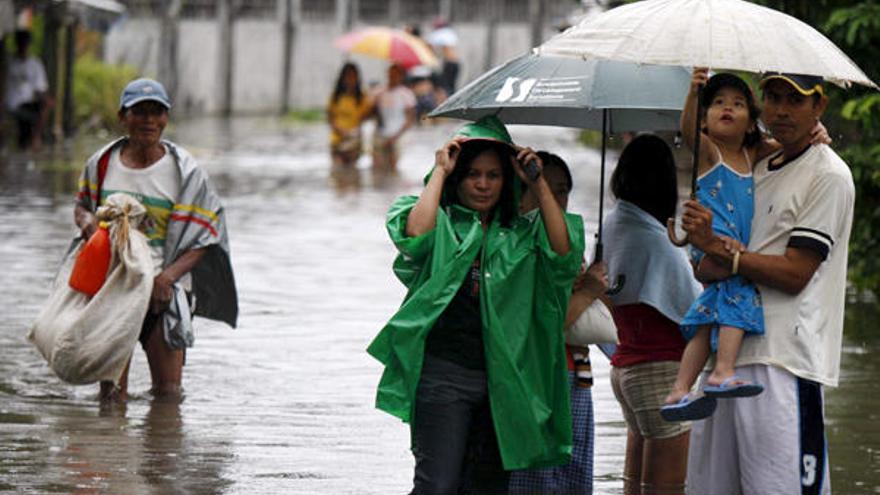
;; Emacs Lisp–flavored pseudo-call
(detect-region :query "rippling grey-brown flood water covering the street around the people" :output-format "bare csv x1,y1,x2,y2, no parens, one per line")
0,119,880,495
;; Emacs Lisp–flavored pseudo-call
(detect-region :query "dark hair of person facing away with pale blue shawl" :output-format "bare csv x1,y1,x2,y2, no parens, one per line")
611,134,678,225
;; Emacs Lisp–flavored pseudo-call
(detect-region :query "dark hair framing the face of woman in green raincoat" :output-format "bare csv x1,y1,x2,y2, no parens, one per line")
440,139,519,227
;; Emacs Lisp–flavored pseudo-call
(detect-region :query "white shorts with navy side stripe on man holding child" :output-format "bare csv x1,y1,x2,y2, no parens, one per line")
687,365,831,495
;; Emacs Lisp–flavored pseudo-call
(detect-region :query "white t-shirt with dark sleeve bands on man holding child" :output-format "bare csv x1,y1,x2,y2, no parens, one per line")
737,145,855,386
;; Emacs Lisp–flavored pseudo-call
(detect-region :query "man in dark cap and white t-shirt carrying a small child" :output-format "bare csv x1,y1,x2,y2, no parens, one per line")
683,73,855,495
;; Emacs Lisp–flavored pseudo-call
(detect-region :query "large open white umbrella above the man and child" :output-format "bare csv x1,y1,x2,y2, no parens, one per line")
535,0,880,246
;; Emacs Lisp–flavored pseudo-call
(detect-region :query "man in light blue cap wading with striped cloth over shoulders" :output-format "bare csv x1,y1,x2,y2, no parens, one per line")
74,79,238,400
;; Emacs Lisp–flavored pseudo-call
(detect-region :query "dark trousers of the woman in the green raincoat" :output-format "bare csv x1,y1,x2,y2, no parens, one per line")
411,355,509,495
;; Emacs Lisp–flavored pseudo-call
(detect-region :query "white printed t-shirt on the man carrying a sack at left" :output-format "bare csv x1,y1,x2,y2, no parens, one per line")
101,148,181,274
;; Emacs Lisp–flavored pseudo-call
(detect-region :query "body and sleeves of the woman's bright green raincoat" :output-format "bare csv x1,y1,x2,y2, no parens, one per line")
368,187,584,470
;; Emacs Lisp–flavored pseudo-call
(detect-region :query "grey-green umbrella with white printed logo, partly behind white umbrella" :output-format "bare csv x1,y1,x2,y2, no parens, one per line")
429,53,691,290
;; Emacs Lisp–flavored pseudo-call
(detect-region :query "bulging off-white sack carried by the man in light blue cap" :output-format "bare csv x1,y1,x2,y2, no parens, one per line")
27,193,154,384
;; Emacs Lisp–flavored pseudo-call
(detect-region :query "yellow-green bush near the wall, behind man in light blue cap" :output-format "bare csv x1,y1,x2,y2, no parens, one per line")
73,54,138,131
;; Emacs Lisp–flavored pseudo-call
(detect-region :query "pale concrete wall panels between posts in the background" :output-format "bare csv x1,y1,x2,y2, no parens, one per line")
105,18,551,115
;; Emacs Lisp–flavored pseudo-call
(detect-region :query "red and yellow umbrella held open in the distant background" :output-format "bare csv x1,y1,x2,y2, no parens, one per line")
334,27,438,69
